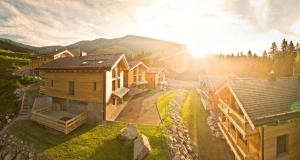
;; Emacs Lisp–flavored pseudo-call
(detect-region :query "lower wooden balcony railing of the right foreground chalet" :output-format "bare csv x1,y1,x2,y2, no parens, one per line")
218,122,259,160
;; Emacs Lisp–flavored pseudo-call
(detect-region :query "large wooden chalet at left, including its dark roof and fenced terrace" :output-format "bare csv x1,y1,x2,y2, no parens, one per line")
32,54,129,133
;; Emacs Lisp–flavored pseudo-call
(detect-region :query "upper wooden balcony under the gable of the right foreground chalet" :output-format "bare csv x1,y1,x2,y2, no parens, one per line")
218,99,258,138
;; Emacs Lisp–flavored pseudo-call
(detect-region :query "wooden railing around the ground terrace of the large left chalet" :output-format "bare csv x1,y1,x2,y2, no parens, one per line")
31,107,87,134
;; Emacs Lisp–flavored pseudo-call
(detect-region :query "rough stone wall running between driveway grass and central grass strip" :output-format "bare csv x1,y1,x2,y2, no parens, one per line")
167,92,198,160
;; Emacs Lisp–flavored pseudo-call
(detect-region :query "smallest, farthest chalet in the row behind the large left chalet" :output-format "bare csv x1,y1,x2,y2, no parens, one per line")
146,67,167,88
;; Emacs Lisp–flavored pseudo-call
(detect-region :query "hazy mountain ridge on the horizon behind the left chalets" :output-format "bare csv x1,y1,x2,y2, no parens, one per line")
0,35,184,55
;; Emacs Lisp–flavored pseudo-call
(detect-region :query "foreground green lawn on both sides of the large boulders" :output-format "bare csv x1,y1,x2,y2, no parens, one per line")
9,121,169,160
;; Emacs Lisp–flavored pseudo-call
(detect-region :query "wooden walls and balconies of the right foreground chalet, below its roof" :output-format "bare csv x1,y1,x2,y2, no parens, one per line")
217,87,300,160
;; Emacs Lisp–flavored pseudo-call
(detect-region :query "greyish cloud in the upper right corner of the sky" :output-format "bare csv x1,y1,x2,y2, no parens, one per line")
223,0,300,35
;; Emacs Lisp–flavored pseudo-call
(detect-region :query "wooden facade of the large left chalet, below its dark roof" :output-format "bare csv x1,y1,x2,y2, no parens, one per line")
35,55,129,132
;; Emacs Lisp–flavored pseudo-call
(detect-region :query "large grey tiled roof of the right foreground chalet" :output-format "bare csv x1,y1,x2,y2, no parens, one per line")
228,78,300,126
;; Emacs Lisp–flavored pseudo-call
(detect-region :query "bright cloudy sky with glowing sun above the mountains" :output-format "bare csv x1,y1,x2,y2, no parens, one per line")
0,0,300,55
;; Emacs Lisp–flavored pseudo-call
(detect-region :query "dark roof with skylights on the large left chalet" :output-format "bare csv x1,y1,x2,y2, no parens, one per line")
39,54,124,69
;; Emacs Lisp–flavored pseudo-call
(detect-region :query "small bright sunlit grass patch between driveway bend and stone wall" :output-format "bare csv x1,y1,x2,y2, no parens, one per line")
156,92,177,126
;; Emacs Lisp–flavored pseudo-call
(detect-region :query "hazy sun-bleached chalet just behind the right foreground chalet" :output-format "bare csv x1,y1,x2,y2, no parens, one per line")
198,75,229,110
